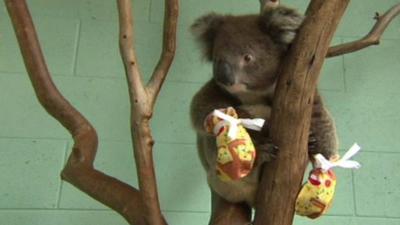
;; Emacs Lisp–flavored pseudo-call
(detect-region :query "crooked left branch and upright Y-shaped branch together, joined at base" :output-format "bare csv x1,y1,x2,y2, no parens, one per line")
5,0,178,225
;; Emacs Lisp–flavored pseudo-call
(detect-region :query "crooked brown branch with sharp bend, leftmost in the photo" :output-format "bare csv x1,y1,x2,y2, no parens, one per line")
5,0,144,225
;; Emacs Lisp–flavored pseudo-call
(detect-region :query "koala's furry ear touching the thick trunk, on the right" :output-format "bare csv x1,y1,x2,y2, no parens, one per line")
261,6,304,45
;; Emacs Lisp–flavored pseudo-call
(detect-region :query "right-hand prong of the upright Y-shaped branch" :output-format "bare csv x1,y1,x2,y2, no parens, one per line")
147,0,179,106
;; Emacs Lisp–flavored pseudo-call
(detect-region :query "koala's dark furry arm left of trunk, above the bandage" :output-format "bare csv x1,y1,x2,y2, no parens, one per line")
190,81,238,135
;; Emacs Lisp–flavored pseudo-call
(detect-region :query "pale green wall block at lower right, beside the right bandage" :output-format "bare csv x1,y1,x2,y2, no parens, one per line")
354,152,400,217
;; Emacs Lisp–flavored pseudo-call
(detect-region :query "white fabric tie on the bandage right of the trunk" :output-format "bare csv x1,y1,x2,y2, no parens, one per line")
314,143,361,171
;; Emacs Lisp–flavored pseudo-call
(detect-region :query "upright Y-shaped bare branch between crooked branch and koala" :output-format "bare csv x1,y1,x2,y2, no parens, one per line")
117,0,179,225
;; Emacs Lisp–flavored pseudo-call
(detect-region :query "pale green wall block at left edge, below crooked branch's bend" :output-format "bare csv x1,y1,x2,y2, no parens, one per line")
0,139,66,208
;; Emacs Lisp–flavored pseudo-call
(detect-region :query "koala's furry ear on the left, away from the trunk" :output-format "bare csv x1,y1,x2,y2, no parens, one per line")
190,13,224,61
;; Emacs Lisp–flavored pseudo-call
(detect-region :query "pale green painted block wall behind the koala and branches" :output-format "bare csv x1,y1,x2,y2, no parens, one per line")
0,0,400,225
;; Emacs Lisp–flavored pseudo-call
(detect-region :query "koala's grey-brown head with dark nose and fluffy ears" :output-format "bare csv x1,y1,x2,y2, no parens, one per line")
191,8,299,94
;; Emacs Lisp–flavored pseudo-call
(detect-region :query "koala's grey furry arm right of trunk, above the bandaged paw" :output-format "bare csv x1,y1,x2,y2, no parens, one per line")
309,92,338,159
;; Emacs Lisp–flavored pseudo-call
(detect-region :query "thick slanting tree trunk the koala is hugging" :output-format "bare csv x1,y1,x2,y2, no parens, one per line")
254,0,349,225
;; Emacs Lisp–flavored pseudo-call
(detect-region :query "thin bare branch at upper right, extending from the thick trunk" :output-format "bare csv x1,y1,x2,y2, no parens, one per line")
326,3,400,57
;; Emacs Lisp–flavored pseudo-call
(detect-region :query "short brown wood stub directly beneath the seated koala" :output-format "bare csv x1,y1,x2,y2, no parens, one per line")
209,191,251,225
